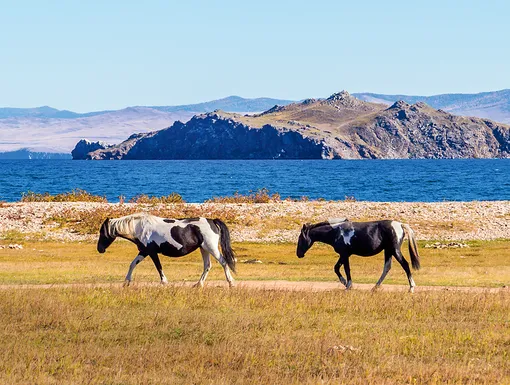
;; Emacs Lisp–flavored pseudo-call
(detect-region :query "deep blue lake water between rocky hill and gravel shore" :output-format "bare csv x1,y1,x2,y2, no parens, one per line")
0,159,510,202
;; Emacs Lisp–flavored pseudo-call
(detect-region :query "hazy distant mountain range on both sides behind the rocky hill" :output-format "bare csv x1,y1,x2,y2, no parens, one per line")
0,90,510,153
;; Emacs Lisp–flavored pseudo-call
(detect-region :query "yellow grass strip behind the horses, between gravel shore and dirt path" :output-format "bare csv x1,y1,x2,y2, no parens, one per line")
0,240,510,287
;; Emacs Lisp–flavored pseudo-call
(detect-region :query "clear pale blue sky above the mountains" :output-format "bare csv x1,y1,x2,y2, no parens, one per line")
0,0,510,112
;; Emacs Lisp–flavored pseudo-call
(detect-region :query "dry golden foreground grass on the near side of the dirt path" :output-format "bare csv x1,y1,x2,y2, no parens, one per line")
0,287,510,385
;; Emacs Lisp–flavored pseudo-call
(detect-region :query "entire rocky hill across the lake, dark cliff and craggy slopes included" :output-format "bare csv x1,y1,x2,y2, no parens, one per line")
73,91,510,159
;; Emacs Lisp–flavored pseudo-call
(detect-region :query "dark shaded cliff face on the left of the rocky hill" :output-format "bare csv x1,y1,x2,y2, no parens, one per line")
82,113,323,159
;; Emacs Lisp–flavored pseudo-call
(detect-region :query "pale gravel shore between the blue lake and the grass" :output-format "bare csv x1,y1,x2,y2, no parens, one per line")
0,201,510,242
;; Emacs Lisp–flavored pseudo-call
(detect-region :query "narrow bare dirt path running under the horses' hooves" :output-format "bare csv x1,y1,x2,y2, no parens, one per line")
0,281,510,293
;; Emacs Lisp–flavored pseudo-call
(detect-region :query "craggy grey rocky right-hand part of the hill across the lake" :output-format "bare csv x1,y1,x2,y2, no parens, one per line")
351,101,510,159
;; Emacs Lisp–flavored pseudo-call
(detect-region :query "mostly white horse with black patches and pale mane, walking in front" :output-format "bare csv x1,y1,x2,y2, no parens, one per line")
97,213,236,286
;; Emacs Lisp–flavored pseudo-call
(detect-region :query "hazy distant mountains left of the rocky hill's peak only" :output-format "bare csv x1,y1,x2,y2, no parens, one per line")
0,96,291,154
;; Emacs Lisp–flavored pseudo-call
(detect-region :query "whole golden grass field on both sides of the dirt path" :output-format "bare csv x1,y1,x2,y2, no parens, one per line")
0,240,510,385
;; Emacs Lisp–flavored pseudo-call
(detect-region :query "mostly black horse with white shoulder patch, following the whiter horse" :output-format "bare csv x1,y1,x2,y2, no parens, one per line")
296,219,420,293
